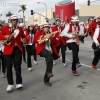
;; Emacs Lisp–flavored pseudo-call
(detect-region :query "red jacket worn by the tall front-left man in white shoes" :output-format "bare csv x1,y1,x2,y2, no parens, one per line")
0,26,25,55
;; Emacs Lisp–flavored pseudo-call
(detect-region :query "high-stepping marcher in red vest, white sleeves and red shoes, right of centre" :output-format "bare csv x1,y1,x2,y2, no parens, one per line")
61,16,79,76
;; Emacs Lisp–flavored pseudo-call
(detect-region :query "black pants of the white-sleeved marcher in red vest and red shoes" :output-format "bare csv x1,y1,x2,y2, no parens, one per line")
67,42,79,71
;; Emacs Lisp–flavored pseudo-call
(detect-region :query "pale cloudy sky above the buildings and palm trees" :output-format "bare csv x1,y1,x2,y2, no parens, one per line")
0,0,100,21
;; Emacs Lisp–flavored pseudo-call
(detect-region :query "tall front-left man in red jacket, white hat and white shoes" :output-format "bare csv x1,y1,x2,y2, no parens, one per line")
0,15,26,92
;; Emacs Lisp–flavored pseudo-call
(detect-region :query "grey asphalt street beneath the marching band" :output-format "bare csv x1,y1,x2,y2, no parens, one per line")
0,37,100,100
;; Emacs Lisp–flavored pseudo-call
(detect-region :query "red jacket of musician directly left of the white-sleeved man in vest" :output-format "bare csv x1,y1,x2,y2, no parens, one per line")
52,26,66,46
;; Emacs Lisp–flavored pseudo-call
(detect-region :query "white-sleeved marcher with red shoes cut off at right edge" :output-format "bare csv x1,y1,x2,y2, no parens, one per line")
92,16,100,69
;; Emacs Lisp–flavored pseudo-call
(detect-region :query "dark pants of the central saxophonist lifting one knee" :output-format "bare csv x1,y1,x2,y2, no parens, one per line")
40,49,53,83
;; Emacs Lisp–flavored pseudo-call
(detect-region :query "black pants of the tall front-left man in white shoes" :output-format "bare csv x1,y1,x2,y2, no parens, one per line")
4,46,22,85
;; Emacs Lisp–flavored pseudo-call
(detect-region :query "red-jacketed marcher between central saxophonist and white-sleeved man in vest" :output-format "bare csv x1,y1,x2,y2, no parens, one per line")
52,18,67,67
